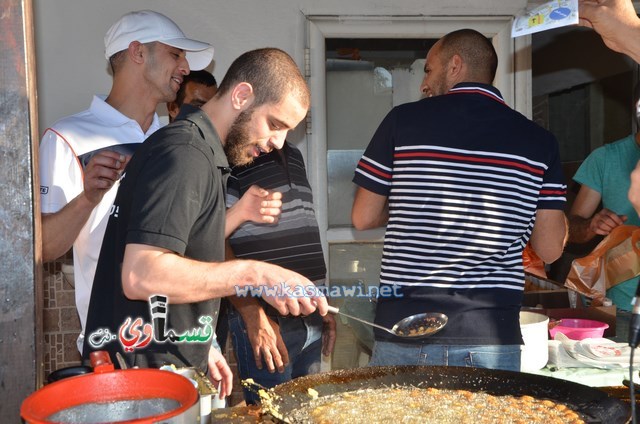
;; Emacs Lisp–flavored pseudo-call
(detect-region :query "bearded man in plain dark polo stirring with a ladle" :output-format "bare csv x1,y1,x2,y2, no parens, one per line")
84,48,327,396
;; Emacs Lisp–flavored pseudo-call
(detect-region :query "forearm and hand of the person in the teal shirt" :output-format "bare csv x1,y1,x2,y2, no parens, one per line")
569,185,627,243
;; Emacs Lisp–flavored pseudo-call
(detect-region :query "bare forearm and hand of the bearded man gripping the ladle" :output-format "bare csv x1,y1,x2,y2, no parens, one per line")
122,244,327,315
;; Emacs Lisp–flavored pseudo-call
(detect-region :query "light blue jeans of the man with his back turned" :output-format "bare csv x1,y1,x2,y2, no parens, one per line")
369,341,520,371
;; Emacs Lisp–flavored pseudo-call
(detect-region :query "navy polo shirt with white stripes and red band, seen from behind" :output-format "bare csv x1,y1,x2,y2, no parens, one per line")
354,84,564,344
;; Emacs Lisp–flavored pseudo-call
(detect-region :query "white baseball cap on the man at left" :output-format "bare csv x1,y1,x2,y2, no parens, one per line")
104,10,213,71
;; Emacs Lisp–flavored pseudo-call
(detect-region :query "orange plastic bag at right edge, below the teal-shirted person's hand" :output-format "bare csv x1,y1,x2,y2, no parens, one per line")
564,225,640,303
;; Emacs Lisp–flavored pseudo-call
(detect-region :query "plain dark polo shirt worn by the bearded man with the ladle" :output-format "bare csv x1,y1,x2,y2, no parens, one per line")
83,107,229,371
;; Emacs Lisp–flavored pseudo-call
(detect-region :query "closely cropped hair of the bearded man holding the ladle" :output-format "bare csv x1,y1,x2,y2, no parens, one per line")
216,48,311,107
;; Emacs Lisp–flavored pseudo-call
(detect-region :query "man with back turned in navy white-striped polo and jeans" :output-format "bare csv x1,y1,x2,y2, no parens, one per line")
352,29,567,370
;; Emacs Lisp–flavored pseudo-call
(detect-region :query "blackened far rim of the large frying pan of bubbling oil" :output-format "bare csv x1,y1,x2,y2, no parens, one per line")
264,366,631,424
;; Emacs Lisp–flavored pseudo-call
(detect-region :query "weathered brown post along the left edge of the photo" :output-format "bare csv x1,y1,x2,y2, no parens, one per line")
0,0,43,423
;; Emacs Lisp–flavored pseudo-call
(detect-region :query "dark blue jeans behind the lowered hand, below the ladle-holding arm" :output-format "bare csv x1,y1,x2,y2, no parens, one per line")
228,308,322,404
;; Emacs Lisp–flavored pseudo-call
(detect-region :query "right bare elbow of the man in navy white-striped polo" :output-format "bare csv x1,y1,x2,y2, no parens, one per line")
529,209,568,263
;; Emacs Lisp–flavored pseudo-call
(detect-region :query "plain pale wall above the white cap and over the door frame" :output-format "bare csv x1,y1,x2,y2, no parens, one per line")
33,0,526,133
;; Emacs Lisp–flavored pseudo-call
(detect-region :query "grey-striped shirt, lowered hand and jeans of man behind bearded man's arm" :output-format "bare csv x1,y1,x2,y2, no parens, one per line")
227,141,336,404
